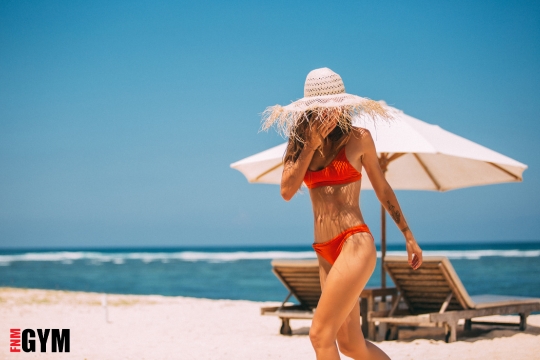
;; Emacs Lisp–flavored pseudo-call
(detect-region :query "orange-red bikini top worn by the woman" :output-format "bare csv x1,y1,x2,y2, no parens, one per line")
304,146,362,189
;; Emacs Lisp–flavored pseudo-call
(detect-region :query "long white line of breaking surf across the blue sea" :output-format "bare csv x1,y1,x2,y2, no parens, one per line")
0,250,540,266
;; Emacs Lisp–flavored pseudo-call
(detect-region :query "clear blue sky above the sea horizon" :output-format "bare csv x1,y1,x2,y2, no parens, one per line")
0,0,540,248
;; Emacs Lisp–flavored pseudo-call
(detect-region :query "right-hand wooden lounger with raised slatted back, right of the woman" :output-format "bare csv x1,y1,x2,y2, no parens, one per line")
368,256,540,342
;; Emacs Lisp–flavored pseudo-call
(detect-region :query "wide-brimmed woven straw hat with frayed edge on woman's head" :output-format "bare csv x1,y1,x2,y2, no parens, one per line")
262,68,392,141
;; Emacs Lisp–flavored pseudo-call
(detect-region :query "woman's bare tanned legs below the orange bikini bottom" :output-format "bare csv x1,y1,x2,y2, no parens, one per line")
309,233,389,359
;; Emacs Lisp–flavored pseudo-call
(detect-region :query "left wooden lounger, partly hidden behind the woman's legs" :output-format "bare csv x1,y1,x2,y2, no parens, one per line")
261,260,397,339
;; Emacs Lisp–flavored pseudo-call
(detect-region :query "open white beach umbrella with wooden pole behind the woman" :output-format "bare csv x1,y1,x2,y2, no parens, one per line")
231,108,527,286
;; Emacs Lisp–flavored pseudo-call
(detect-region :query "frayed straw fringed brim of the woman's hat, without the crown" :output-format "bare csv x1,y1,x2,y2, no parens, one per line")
261,97,393,142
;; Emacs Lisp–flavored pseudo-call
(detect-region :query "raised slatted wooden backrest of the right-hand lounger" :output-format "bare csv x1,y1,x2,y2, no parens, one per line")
385,256,474,314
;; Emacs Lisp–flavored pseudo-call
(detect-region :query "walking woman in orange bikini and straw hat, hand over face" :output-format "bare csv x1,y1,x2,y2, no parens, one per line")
264,68,422,359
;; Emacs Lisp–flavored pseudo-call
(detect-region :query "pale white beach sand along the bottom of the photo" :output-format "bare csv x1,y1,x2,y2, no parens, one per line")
0,288,540,360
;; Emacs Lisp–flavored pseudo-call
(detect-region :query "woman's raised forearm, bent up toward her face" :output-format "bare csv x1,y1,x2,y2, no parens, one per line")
281,144,316,201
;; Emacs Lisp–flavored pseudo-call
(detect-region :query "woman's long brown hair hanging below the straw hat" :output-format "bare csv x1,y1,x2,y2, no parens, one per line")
283,110,352,163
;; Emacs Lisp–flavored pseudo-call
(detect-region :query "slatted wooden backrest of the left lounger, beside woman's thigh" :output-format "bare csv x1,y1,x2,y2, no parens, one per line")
272,260,321,309
